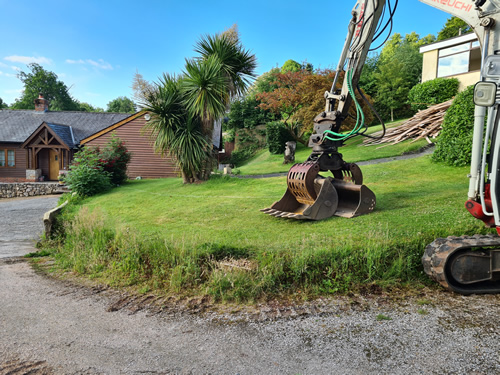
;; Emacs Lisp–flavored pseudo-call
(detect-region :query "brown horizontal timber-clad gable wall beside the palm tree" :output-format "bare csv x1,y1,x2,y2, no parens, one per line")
86,116,178,179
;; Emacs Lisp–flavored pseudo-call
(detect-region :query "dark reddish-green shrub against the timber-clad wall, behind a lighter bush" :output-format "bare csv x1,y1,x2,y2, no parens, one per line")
100,134,132,185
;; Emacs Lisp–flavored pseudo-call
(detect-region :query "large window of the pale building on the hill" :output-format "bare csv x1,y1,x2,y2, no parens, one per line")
437,41,481,77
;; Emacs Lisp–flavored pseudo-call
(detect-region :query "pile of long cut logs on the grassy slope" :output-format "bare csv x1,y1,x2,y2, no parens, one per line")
363,99,453,147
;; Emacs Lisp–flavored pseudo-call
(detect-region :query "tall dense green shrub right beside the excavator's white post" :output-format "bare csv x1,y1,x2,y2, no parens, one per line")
432,86,474,166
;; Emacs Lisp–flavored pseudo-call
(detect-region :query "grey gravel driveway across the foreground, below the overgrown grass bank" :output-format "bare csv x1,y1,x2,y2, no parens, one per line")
0,261,500,375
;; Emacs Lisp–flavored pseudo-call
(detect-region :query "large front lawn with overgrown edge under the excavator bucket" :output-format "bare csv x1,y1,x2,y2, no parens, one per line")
44,157,492,301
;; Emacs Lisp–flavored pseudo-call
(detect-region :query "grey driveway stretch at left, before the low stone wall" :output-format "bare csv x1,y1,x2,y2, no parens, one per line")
0,195,60,258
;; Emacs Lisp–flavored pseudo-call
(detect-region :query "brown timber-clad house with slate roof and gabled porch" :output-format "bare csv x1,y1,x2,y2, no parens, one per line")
0,96,177,182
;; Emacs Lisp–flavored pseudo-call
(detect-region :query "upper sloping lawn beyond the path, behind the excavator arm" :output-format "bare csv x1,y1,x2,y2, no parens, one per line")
237,121,427,175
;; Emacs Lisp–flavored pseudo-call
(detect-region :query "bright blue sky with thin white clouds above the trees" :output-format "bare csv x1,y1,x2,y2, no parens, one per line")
0,0,449,109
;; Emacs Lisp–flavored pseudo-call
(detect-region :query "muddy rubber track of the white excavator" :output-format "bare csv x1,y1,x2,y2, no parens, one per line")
422,234,500,290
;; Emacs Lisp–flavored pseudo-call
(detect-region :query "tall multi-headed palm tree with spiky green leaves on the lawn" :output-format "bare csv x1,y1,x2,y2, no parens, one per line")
144,33,256,182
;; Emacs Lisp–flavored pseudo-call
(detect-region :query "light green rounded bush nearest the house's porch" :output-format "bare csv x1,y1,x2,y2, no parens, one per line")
64,147,112,196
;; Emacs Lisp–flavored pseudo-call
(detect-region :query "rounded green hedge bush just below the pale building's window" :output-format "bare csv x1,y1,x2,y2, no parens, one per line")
408,78,460,110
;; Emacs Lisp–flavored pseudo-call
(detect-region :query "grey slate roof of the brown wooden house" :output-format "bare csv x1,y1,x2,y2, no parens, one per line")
0,109,133,145
